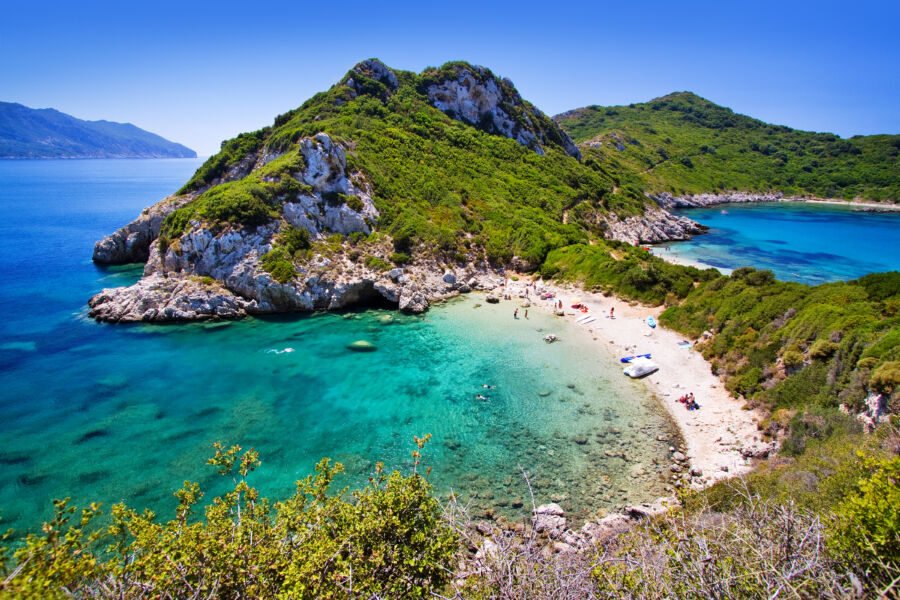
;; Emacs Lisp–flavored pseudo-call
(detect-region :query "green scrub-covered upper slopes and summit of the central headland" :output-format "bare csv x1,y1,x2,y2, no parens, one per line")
163,60,647,266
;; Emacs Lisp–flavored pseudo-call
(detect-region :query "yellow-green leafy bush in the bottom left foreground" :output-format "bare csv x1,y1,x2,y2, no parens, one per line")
0,440,458,599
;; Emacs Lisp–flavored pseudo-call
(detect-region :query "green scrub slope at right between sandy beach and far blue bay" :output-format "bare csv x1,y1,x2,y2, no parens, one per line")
660,267,900,425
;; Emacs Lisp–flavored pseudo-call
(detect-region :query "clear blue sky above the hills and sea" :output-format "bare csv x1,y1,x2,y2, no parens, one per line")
0,0,900,155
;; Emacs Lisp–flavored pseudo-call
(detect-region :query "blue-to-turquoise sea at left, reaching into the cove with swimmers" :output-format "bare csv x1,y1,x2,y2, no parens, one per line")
0,160,676,531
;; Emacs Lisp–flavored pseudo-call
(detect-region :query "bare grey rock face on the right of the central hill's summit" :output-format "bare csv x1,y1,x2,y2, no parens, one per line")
426,66,581,159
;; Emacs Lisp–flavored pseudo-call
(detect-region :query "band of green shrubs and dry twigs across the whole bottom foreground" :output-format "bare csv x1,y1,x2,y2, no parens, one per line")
0,429,900,600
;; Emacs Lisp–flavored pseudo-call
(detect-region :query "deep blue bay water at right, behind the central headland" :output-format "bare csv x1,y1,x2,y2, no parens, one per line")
656,202,900,285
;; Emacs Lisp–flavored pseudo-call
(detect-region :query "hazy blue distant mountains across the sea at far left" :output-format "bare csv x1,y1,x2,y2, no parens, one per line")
0,102,197,158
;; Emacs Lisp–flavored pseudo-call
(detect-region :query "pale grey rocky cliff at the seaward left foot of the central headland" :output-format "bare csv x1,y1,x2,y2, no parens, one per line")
89,133,506,322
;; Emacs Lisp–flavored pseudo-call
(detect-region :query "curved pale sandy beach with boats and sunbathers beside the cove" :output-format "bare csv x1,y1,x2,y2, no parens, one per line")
501,277,761,482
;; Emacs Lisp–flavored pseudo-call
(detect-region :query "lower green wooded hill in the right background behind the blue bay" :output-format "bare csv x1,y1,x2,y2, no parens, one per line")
554,92,900,202
